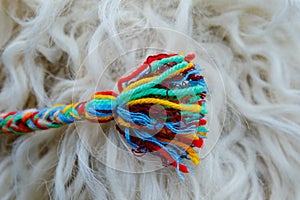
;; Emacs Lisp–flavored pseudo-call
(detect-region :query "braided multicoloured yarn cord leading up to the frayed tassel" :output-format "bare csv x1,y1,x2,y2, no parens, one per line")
0,92,116,134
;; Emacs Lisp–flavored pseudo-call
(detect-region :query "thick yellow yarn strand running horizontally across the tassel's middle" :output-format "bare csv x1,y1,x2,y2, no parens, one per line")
127,98,201,113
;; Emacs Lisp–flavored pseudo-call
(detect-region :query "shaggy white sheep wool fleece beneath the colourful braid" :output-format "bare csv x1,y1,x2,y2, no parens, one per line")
0,0,300,200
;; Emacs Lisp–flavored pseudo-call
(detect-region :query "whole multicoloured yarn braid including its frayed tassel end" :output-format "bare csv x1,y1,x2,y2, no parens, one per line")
0,54,207,177
